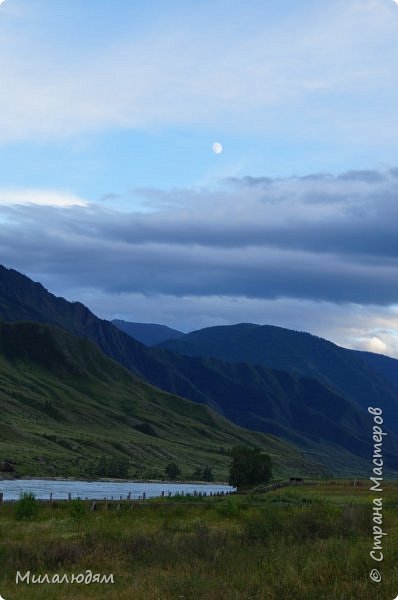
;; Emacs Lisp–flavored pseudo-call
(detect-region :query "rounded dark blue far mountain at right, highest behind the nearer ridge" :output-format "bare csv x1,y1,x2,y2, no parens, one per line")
158,323,398,432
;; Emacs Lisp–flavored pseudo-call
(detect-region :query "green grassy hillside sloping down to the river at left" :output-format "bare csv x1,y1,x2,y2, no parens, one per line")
0,322,325,480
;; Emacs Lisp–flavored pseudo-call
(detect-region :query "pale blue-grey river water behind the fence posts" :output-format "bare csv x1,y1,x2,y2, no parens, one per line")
0,479,234,501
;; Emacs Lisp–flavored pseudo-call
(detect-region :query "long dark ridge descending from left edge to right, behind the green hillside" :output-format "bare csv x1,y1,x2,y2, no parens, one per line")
0,267,398,475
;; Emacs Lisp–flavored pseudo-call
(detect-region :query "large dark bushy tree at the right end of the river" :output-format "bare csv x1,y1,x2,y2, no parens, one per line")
229,446,272,488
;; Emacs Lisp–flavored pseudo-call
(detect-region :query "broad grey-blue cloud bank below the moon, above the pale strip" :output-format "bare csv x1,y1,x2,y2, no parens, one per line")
0,165,398,305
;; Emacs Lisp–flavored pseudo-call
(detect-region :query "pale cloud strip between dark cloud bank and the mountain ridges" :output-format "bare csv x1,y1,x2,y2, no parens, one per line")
33,290,398,357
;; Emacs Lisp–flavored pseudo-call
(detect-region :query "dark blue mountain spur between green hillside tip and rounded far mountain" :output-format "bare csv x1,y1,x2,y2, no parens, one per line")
148,356,398,475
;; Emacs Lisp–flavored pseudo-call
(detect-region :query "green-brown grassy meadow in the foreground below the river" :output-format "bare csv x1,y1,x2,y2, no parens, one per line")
0,481,398,600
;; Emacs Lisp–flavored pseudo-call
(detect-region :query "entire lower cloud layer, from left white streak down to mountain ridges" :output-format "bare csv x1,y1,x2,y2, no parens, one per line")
0,164,398,353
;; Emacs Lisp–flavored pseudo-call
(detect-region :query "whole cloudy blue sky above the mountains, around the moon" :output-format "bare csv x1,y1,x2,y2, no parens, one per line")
0,0,398,357
